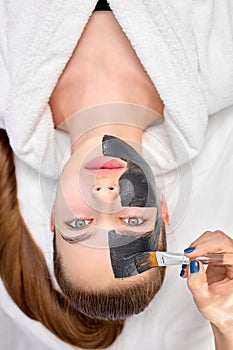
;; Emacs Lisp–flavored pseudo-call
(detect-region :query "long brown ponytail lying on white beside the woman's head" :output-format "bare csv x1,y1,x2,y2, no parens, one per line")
0,130,124,349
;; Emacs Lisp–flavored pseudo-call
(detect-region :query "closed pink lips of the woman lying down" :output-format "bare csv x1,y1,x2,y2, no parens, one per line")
84,157,126,175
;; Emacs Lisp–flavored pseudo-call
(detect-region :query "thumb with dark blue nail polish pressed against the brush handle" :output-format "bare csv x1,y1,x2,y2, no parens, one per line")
188,260,210,309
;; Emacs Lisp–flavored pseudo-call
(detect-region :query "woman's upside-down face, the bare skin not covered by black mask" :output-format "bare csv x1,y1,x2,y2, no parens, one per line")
54,137,165,290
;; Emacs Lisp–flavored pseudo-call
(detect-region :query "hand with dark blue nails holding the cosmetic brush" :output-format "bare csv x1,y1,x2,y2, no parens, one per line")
181,231,233,350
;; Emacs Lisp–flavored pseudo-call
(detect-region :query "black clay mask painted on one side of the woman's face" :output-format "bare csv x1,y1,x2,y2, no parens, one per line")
102,135,160,278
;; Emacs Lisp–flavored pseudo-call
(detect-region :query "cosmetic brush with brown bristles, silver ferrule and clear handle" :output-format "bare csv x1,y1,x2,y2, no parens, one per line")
134,251,233,273
